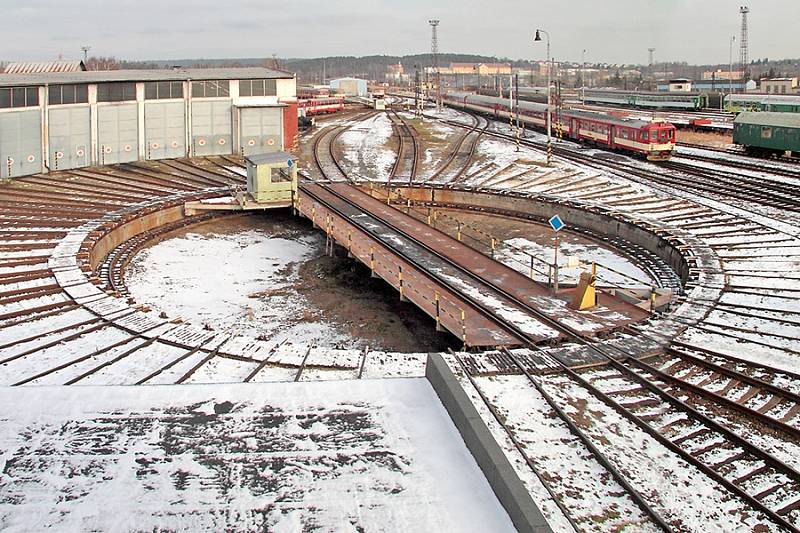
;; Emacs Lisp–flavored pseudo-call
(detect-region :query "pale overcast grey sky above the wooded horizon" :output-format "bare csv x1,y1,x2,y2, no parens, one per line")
0,0,800,63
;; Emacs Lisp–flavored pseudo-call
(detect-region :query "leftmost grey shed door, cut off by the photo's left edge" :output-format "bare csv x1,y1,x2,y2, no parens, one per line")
0,109,43,178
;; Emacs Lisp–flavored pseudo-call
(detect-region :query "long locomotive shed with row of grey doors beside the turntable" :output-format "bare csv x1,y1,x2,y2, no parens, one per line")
0,68,297,178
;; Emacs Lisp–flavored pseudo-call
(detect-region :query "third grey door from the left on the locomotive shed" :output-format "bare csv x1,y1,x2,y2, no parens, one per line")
97,104,139,165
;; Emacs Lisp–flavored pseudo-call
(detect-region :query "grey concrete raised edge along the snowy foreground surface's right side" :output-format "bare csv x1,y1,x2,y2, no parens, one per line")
425,354,552,533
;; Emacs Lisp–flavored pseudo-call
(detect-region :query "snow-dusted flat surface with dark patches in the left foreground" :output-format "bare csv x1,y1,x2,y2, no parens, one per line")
0,379,514,533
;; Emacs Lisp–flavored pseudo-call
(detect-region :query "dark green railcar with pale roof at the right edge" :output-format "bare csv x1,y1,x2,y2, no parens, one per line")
733,111,800,156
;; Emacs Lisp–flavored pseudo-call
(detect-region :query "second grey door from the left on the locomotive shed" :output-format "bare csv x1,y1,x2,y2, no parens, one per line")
49,106,92,170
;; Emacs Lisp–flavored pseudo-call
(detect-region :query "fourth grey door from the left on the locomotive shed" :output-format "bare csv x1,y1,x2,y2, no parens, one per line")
144,102,186,159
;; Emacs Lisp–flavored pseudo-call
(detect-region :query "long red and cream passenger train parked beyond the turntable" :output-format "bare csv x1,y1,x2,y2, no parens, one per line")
444,92,675,161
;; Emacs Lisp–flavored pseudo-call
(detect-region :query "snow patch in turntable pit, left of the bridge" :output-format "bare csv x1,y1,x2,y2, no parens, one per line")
126,230,358,344
